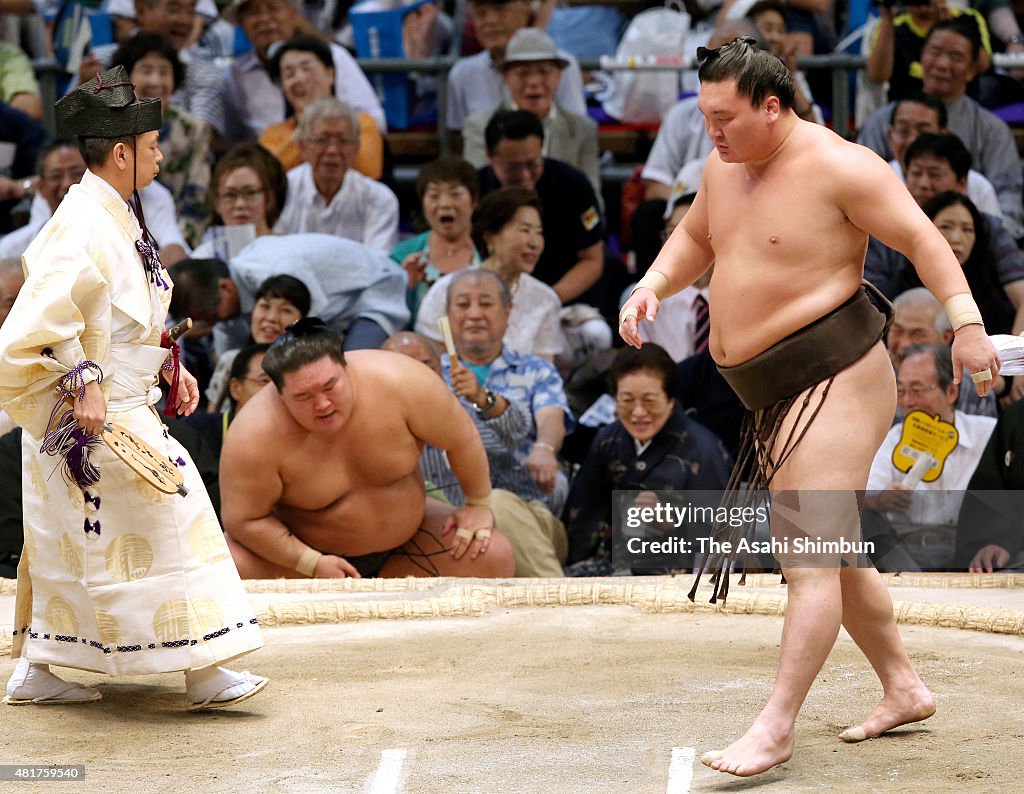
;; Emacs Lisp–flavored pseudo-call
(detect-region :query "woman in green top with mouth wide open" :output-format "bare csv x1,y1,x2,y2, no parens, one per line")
391,156,481,328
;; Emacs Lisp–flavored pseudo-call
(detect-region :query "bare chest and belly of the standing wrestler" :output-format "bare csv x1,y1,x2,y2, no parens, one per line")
700,122,876,366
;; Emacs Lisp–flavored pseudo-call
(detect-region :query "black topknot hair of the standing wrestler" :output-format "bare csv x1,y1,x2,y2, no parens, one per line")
697,36,795,109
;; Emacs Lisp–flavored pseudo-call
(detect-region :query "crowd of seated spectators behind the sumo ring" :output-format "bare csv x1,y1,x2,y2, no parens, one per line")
0,0,1024,577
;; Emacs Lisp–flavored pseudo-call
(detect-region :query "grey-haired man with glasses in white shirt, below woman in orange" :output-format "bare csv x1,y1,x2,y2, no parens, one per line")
274,97,398,254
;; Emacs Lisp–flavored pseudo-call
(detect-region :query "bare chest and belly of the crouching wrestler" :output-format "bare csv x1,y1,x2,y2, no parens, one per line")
231,351,435,556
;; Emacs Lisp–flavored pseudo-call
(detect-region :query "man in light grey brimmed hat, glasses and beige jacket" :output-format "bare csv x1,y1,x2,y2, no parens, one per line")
462,28,601,198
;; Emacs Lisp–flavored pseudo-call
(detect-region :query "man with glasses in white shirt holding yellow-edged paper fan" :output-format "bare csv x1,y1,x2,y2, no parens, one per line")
864,342,995,571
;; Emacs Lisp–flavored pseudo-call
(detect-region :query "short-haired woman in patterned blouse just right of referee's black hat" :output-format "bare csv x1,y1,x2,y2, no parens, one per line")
111,33,210,246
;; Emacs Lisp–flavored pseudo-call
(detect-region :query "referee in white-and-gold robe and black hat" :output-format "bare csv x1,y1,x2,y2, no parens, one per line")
0,67,266,709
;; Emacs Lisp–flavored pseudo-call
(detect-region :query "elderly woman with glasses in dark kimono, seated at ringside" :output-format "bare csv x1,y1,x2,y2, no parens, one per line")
563,343,732,576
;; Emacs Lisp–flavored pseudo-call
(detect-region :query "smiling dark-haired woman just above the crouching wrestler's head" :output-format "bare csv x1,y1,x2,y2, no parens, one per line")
206,275,311,412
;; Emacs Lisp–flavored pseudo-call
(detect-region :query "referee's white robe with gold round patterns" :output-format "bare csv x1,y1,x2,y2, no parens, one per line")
0,171,263,675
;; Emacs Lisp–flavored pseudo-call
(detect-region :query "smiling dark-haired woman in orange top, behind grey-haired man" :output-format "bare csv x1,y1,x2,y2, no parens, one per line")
259,35,384,179
